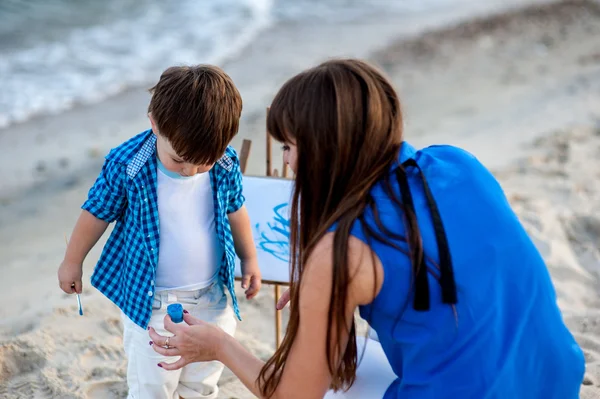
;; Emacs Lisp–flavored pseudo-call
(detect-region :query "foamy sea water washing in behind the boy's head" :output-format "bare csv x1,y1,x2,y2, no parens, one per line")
0,0,516,128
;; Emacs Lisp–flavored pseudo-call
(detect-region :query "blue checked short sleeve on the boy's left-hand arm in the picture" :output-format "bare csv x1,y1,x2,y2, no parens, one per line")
81,160,127,223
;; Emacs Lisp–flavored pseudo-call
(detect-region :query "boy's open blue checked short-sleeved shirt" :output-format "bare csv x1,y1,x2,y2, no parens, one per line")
82,130,244,329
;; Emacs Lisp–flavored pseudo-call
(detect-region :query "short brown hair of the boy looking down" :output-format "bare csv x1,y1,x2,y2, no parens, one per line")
148,65,242,165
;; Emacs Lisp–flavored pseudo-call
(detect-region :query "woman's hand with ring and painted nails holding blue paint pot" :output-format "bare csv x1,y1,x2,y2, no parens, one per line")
149,312,229,370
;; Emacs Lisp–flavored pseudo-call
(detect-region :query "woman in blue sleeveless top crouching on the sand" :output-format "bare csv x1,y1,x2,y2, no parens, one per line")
150,60,584,399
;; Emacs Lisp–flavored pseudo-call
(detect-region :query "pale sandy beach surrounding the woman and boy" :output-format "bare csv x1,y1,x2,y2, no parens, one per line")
0,0,600,399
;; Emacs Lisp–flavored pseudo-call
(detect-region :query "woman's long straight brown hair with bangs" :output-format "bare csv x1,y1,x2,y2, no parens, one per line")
258,59,408,397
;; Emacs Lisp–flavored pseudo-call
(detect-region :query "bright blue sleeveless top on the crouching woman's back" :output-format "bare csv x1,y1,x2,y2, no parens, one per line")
352,143,584,399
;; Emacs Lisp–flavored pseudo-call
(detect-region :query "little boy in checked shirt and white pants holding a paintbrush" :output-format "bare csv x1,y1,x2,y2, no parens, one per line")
58,65,261,399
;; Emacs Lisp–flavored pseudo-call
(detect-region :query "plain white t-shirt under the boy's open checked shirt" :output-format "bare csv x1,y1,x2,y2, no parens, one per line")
156,159,223,291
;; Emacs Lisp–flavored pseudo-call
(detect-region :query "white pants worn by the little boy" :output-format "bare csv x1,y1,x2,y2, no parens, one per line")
122,283,237,399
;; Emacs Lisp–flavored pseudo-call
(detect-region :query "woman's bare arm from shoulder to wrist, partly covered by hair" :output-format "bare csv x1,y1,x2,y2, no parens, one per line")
218,234,383,399
